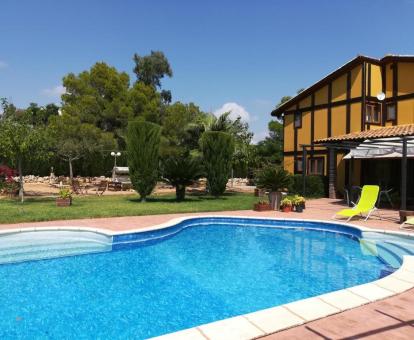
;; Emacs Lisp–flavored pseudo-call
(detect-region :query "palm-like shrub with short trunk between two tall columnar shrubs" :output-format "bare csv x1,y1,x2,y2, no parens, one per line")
161,156,204,201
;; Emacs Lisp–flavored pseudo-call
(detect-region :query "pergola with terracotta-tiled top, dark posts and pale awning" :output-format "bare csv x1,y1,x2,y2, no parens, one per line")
301,124,414,210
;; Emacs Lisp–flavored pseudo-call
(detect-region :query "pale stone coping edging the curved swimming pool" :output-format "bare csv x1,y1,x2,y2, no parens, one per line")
0,214,414,340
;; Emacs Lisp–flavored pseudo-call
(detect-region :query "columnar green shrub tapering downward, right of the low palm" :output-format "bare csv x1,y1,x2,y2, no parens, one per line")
200,131,234,196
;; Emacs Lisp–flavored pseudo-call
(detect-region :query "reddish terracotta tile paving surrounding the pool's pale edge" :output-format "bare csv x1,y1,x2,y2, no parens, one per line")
0,199,414,340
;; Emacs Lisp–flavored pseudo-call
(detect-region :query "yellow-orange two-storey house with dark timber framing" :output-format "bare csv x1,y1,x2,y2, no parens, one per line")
272,55,414,201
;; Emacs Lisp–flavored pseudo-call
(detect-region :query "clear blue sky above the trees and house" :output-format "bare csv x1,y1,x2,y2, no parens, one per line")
0,0,414,140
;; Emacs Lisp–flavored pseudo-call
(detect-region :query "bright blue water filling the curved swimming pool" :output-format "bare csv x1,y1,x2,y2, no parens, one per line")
0,219,404,339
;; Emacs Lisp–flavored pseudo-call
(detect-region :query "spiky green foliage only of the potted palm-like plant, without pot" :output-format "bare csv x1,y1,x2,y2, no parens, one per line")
256,165,292,192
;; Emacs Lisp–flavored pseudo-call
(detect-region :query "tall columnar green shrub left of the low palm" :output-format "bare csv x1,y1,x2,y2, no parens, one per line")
127,122,161,202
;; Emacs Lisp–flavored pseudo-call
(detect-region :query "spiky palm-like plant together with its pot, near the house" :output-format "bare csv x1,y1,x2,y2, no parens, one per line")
256,164,292,210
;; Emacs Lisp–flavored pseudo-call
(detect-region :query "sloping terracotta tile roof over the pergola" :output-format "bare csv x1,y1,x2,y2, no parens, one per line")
314,124,414,143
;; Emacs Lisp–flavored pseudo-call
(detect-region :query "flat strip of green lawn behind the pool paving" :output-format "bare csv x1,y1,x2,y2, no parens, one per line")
0,193,258,223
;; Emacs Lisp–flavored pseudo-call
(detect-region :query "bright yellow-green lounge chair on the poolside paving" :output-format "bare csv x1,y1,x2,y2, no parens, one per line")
332,185,381,222
